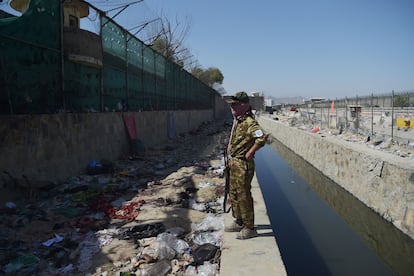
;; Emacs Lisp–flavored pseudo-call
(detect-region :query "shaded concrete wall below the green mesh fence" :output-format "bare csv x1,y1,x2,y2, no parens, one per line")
0,110,214,196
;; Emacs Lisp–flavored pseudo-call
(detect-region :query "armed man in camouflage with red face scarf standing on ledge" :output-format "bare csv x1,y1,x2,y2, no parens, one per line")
225,92,266,240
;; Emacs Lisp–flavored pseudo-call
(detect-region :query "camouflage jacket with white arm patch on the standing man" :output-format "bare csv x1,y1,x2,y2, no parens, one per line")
229,113,266,159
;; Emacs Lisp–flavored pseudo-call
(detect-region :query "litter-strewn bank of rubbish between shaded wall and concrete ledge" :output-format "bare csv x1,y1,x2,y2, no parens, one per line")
0,120,230,275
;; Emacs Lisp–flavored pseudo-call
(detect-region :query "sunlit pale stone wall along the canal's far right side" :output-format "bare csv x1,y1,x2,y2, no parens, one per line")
258,116,414,238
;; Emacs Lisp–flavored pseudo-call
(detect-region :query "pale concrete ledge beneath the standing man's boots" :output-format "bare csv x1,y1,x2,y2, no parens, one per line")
220,177,287,276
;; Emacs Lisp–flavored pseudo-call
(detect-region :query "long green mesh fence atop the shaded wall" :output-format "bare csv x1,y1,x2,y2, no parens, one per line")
0,0,216,114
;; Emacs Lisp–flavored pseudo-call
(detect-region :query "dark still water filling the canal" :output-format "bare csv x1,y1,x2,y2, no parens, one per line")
256,141,414,276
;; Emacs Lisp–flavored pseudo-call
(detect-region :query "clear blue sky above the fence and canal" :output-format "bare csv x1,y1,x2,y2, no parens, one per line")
0,0,414,99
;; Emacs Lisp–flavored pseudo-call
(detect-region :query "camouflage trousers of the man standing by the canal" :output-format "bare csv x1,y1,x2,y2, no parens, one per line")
229,158,254,228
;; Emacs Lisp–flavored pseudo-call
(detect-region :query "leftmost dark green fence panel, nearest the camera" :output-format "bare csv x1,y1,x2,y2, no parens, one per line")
0,0,62,114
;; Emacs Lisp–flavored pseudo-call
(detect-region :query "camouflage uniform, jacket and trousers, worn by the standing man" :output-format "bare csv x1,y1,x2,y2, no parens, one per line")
228,115,266,228
